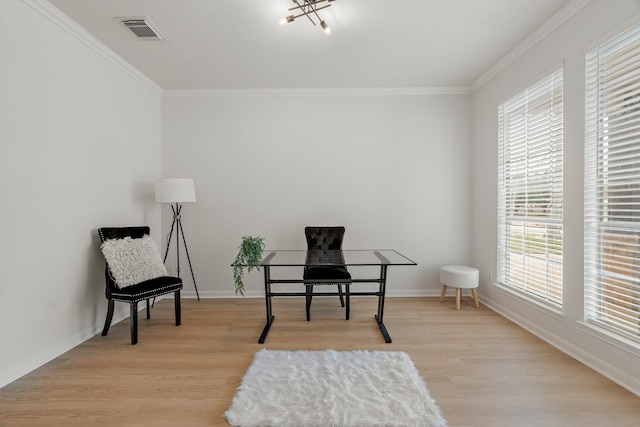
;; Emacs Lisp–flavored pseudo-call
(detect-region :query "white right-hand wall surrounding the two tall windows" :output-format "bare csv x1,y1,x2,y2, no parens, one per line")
472,0,640,394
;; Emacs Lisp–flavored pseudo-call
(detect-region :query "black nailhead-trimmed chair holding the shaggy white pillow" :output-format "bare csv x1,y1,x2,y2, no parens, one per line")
98,226,182,344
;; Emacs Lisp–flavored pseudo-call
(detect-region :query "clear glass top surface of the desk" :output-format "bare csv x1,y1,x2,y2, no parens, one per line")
260,249,416,267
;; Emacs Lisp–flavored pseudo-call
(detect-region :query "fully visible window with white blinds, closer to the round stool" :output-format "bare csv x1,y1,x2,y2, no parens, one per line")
498,68,563,309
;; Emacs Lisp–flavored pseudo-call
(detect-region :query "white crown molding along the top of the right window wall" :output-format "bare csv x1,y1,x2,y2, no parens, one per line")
470,0,591,92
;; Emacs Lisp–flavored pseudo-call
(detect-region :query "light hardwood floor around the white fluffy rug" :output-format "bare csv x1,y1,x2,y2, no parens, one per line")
0,297,640,427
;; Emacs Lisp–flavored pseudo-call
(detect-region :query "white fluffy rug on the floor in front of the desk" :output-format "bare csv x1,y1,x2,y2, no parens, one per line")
225,350,447,427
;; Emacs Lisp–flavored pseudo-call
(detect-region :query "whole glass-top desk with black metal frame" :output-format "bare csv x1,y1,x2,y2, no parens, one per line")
258,249,417,344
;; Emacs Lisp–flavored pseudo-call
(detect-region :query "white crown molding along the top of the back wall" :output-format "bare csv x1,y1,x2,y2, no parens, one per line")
162,86,471,98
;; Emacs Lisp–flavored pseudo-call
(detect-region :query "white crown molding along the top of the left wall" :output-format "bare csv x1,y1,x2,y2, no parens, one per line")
22,0,162,95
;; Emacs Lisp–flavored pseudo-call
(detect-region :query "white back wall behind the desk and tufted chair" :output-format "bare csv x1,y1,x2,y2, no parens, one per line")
162,92,471,296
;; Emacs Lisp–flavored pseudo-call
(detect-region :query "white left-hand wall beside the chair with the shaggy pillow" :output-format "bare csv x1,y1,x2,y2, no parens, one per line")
0,0,160,386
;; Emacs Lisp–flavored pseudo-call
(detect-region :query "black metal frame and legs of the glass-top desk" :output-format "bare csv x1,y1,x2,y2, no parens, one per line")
258,252,391,344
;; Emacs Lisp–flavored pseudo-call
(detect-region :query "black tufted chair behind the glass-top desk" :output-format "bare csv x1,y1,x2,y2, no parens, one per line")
303,227,351,321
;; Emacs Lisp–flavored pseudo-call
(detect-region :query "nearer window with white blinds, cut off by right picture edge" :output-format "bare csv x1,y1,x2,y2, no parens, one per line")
585,25,640,341
